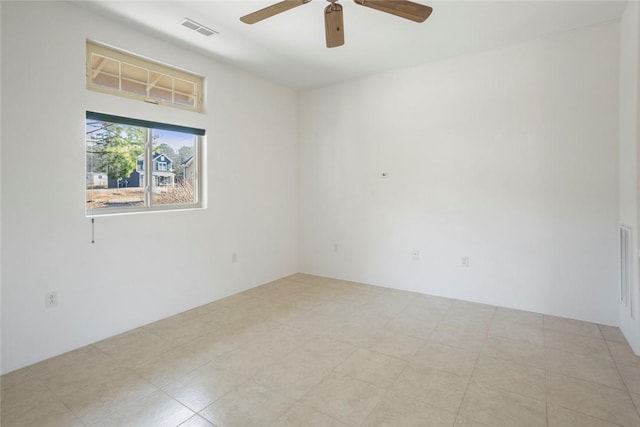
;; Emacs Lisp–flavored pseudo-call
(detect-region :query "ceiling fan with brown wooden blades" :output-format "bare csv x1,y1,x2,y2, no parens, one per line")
240,0,433,47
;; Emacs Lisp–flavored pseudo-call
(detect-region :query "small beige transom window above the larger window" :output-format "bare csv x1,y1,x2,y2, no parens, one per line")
87,42,203,111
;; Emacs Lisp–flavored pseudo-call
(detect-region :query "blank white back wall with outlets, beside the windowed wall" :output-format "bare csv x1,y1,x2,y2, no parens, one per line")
300,23,619,325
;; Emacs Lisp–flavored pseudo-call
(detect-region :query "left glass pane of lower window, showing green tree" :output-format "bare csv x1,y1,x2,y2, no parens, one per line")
86,120,145,211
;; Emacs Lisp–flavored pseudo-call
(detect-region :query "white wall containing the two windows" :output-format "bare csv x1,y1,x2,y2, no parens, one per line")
1,2,299,372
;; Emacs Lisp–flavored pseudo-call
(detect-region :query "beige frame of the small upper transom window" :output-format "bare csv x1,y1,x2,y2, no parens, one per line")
86,40,204,113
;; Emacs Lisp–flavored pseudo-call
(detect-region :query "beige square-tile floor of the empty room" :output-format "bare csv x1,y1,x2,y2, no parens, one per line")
1,274,640,427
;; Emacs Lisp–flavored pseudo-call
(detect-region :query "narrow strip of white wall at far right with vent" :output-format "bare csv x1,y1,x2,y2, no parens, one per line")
619,1,640,353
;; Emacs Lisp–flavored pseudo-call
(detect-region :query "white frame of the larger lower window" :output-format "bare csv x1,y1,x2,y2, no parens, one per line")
84,111,206,218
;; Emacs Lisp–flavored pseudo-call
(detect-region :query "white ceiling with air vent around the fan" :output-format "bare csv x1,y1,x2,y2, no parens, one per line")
74,0,637,89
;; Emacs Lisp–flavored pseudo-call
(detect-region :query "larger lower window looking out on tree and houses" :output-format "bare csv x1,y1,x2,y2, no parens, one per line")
86,111,205,216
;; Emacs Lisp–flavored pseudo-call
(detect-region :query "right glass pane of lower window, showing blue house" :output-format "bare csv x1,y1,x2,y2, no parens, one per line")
151,129,197,205
